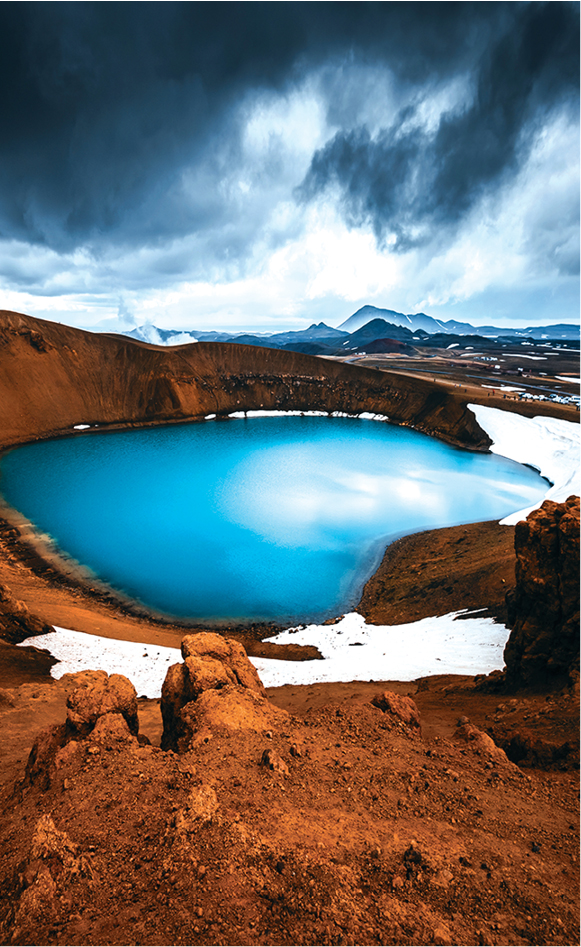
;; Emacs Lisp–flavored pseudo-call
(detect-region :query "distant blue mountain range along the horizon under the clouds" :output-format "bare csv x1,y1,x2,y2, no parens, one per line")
124,306,579,355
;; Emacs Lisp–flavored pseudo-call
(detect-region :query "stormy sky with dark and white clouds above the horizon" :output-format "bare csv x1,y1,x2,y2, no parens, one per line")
0,2,579,332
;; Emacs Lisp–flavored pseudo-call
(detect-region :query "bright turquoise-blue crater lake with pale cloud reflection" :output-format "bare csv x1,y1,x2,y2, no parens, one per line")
0,417,546,623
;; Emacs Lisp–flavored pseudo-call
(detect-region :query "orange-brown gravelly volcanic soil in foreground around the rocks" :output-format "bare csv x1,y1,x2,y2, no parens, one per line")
0,678,579,944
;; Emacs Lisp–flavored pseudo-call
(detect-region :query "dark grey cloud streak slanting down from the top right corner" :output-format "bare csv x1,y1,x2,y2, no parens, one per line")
299,3,579,260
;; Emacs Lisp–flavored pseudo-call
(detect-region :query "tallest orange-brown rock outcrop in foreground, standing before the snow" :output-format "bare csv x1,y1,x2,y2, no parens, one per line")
161,633,287,752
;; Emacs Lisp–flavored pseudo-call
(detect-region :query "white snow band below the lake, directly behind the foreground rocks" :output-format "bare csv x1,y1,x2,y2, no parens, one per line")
20,612,509,698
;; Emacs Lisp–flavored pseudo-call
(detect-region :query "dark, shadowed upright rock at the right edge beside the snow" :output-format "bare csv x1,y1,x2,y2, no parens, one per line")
504,496,579,688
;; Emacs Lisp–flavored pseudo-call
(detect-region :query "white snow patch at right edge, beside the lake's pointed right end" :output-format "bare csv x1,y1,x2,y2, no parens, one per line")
468,404,580,526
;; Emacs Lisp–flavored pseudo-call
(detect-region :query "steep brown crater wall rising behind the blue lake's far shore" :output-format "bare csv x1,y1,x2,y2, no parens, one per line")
0,311,490,450
